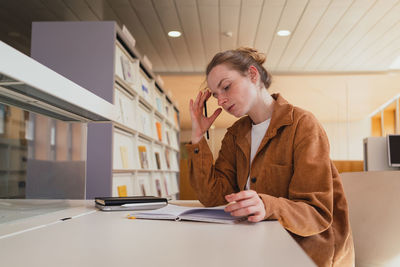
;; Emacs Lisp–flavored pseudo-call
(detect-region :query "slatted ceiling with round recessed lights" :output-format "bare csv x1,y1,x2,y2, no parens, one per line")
0,0,400,73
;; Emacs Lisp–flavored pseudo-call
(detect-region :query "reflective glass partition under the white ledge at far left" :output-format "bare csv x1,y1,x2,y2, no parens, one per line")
0,103,87,199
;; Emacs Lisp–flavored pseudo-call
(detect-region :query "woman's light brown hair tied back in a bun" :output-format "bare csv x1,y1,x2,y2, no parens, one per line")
206,47,271,89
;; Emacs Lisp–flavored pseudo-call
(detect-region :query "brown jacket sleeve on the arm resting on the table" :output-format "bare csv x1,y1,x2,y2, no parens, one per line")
260,115,333,237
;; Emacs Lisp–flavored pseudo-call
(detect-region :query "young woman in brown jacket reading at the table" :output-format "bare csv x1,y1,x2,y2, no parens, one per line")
187,48,354,266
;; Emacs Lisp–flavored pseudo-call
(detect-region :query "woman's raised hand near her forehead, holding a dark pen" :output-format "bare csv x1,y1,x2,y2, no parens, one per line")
189,90,222,144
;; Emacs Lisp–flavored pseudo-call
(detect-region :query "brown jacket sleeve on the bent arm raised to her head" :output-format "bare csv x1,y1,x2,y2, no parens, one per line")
186,131,238,206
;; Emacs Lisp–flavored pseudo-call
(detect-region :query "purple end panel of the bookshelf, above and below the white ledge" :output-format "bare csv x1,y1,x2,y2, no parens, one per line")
31,21,116,199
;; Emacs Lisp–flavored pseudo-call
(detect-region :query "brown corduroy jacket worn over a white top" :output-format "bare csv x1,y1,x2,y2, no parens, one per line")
187,94,354,266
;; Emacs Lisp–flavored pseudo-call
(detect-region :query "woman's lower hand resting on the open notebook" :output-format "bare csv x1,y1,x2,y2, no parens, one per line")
225,190,265,222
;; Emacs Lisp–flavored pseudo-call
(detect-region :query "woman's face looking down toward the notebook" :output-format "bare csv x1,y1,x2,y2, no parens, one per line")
207,64,259,117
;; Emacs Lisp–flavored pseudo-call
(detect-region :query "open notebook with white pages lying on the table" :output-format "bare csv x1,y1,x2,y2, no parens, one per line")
130,204,247,224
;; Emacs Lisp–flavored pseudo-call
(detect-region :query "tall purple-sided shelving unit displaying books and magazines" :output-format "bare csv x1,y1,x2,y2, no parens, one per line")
31,22,179,199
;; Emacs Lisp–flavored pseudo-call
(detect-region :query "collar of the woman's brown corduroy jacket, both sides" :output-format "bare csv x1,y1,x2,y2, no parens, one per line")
236,94,293,158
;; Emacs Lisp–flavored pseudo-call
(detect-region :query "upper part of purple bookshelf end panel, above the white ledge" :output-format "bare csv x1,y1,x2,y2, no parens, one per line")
31,21,116,103
